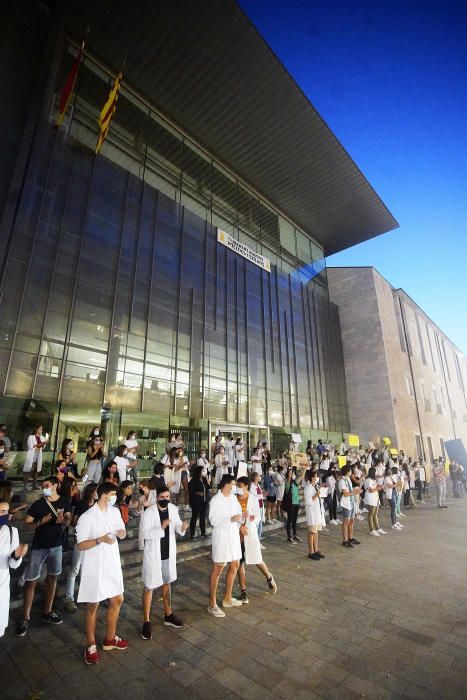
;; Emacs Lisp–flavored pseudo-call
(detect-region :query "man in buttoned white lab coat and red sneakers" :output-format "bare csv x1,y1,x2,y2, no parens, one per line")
76,482,128,665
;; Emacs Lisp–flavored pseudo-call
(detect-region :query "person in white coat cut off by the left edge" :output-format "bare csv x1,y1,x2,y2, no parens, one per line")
0,502,28,637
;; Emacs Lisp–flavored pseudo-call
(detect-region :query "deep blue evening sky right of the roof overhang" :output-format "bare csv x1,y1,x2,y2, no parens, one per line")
240,0,467,354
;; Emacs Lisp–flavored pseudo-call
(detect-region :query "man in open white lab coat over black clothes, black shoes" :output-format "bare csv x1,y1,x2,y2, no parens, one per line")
139,486,188,639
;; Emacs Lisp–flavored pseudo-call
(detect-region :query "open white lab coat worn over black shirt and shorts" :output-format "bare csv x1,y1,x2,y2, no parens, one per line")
139,503,185,590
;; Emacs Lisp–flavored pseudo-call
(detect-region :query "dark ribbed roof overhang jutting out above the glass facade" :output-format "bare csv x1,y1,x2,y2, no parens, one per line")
62,0,398,255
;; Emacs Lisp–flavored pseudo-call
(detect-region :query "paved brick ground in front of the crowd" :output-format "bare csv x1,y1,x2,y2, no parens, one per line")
0,492,467,700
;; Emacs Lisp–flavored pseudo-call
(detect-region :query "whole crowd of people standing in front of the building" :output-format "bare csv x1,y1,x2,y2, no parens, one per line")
0,426,465,665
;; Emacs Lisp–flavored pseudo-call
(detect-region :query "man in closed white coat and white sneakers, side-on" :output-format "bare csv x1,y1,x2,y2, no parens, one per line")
208,474,248,617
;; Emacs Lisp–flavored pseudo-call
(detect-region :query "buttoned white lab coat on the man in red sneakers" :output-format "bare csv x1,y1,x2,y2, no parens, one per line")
76,503,125,603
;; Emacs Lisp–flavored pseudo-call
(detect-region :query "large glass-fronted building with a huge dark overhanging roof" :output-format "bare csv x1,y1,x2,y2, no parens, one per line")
0,0,397,470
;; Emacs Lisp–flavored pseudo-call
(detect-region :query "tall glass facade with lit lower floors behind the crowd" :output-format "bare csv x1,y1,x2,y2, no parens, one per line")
0,41,348,468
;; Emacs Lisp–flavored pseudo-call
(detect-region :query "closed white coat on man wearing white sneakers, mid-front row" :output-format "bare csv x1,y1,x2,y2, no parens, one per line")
209,491,242,564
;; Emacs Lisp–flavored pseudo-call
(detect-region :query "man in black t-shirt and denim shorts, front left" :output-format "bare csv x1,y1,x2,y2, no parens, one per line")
16,476,71,637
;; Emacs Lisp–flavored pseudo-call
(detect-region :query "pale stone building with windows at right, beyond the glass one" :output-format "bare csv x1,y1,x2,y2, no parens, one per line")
328,267,467,462
